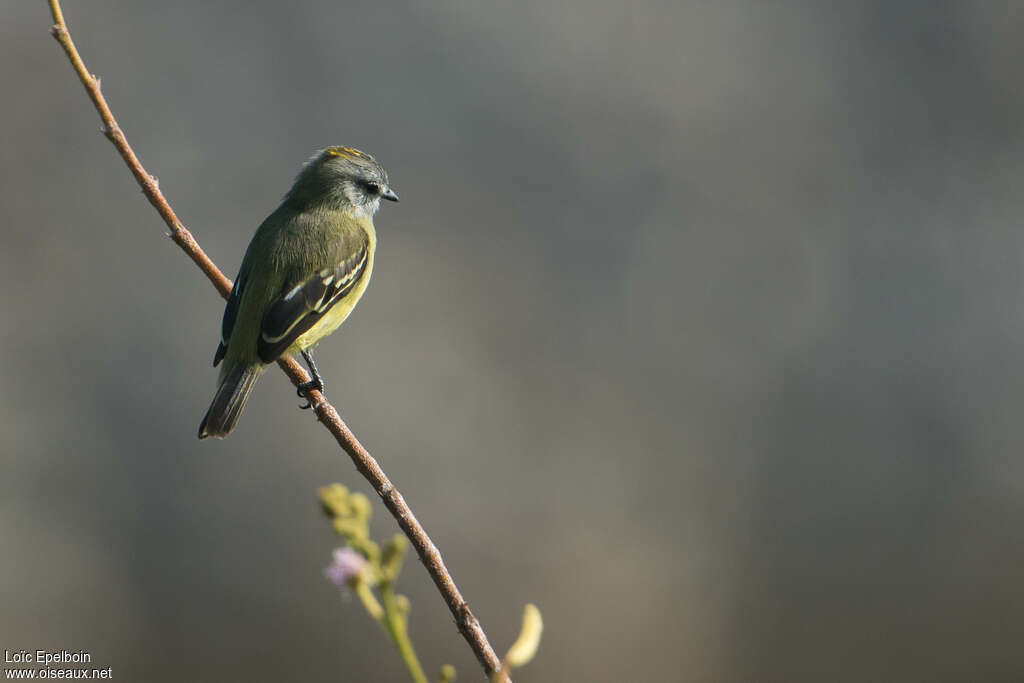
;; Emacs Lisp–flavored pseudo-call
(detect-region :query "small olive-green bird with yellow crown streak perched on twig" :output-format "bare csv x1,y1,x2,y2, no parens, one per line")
199,146,398,438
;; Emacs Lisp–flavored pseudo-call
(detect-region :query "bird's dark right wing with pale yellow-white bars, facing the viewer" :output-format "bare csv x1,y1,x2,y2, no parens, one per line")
256,234,370,362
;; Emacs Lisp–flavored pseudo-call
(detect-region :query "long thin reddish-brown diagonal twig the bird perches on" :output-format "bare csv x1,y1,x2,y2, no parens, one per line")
49,0,501,676
